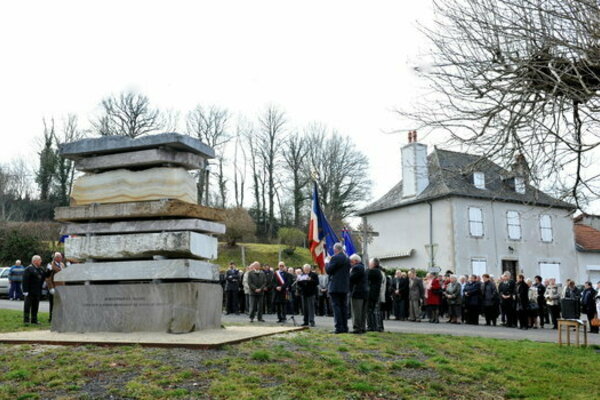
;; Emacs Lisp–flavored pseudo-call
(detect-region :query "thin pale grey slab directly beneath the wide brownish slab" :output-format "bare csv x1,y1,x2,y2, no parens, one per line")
61,218,225,235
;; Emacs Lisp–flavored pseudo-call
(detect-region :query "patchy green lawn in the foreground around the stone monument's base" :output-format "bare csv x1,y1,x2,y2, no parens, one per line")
0,311,600,400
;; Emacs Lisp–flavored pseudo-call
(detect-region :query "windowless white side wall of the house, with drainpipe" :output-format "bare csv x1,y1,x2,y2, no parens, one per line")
367,199,454,269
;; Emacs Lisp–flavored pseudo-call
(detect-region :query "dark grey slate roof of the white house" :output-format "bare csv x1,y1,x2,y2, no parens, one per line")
358,148,575,215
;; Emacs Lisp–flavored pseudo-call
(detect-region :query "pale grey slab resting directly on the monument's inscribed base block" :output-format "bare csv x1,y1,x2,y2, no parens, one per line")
55,259,219,283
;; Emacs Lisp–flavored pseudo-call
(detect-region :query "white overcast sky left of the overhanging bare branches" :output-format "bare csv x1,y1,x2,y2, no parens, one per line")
0,0,430,203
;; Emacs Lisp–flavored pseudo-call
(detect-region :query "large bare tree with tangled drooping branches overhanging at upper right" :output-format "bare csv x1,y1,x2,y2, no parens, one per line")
401,0,600,208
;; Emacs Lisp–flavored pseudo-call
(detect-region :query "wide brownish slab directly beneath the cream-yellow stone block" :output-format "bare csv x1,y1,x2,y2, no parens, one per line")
54,199,225,222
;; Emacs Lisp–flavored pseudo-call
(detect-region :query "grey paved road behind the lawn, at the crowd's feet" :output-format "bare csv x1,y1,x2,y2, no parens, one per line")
0,300,600,345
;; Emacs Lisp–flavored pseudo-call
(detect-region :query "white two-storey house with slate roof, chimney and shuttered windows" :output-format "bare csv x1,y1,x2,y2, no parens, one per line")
358,135,580,282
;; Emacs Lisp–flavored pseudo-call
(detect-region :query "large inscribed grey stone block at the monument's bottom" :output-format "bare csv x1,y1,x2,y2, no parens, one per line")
52,282,223,333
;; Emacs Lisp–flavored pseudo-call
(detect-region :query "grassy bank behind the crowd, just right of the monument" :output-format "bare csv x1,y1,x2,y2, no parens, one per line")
215,243,313,269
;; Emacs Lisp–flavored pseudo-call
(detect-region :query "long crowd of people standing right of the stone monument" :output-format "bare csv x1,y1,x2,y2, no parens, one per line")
222,244,600,333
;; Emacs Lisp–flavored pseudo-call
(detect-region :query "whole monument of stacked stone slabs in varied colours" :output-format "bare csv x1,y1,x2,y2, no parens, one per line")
52,133,225,333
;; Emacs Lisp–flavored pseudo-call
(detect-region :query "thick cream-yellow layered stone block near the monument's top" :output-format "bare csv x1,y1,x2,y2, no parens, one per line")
71,168,198,206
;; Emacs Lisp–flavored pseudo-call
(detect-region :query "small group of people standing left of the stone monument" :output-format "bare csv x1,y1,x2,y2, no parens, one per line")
8,252,65,325
